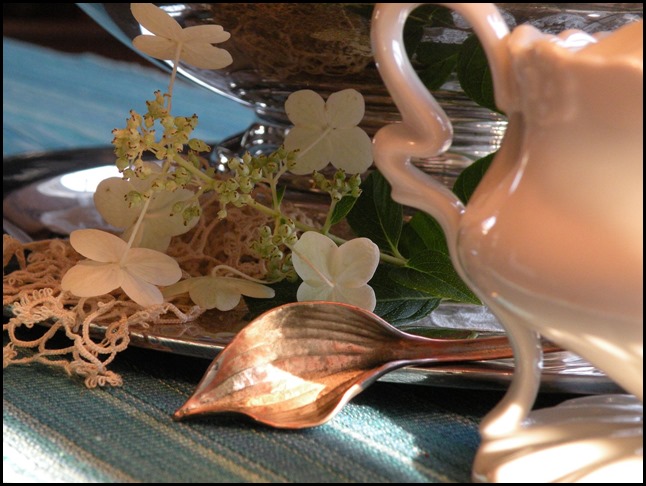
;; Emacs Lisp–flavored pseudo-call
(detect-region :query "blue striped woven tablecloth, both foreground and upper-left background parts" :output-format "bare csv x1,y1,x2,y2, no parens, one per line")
3,39,572,483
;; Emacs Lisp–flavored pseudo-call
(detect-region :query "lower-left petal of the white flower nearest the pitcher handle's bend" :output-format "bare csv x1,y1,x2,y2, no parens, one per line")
284,126,331,175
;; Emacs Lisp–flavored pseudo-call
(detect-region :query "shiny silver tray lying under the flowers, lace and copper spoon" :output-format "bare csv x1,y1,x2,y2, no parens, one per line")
3,147,623,394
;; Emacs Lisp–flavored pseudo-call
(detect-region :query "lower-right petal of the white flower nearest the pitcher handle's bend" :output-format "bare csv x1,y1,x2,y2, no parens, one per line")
327,127,373,174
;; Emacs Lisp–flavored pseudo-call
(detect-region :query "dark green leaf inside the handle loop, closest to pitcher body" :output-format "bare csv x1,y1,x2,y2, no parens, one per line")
457,35,499,111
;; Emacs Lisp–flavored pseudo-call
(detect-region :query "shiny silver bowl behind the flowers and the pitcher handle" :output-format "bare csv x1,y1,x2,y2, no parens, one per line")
78,3,643,183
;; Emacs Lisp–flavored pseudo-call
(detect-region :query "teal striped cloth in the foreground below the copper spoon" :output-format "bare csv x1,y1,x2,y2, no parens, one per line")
3,349,512,483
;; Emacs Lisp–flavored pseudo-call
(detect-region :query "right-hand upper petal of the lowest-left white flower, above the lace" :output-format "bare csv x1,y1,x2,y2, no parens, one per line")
123,248,182,285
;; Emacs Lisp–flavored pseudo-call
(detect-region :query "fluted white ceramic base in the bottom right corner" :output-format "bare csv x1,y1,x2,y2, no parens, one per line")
474,395,644,484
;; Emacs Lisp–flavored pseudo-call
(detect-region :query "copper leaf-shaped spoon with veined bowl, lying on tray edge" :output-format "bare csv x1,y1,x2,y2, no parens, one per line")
174,302,552,429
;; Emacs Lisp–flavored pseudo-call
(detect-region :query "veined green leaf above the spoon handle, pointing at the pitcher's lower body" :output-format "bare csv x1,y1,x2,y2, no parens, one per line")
390,250,480,304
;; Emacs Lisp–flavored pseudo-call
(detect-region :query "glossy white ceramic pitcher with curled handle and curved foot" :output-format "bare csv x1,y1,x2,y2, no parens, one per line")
372,3,643,482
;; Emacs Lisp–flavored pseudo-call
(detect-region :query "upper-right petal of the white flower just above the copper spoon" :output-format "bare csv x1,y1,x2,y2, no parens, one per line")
332,238,379,287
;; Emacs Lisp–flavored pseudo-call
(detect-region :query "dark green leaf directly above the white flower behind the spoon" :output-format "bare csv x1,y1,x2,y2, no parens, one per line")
346,171,404,253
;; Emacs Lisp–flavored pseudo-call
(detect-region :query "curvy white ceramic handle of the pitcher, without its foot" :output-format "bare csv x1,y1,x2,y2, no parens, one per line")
371,3,510,257
